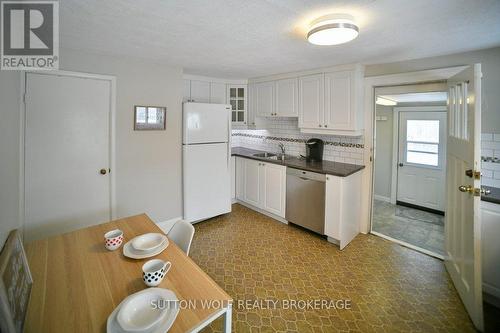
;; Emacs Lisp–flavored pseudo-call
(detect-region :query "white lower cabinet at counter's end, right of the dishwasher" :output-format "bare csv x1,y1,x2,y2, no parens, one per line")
325,172,362,250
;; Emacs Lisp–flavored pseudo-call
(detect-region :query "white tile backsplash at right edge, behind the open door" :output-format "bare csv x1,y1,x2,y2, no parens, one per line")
481,133,500,187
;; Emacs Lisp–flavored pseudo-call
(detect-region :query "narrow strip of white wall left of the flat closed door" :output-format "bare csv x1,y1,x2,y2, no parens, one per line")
0,71,21,248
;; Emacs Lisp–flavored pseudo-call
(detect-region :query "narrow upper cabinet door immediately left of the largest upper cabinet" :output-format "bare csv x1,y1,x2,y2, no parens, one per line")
275,78,299,117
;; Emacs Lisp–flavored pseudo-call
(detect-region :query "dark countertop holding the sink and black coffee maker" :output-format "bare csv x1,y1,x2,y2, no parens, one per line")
231,147,365,177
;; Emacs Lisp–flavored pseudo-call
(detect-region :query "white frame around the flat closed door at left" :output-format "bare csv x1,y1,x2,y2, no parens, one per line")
19,70,116,236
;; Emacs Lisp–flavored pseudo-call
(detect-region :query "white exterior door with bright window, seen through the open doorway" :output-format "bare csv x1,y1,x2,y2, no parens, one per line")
397,111,446,212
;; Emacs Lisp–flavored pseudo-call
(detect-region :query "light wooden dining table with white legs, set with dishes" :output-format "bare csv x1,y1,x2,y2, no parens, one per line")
24,214,232,333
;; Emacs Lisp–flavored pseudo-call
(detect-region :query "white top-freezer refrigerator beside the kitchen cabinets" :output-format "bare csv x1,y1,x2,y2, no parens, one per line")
182,102,231,223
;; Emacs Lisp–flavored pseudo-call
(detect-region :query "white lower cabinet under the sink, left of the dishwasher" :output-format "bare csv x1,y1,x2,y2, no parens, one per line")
236,157,286,218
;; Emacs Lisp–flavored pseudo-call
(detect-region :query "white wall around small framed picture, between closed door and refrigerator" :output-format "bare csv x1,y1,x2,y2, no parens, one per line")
60,50,182,222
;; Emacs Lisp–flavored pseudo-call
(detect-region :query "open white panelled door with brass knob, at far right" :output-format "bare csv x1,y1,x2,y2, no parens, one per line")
445,64,483,331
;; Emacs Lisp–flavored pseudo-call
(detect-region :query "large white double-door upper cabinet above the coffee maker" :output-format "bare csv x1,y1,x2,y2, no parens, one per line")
299,65,363,136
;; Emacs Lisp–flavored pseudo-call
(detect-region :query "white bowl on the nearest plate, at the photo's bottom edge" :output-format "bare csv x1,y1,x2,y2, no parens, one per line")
116,289,166,332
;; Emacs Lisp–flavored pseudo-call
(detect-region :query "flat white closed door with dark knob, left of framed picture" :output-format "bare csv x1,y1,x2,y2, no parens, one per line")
24,73,112,240
